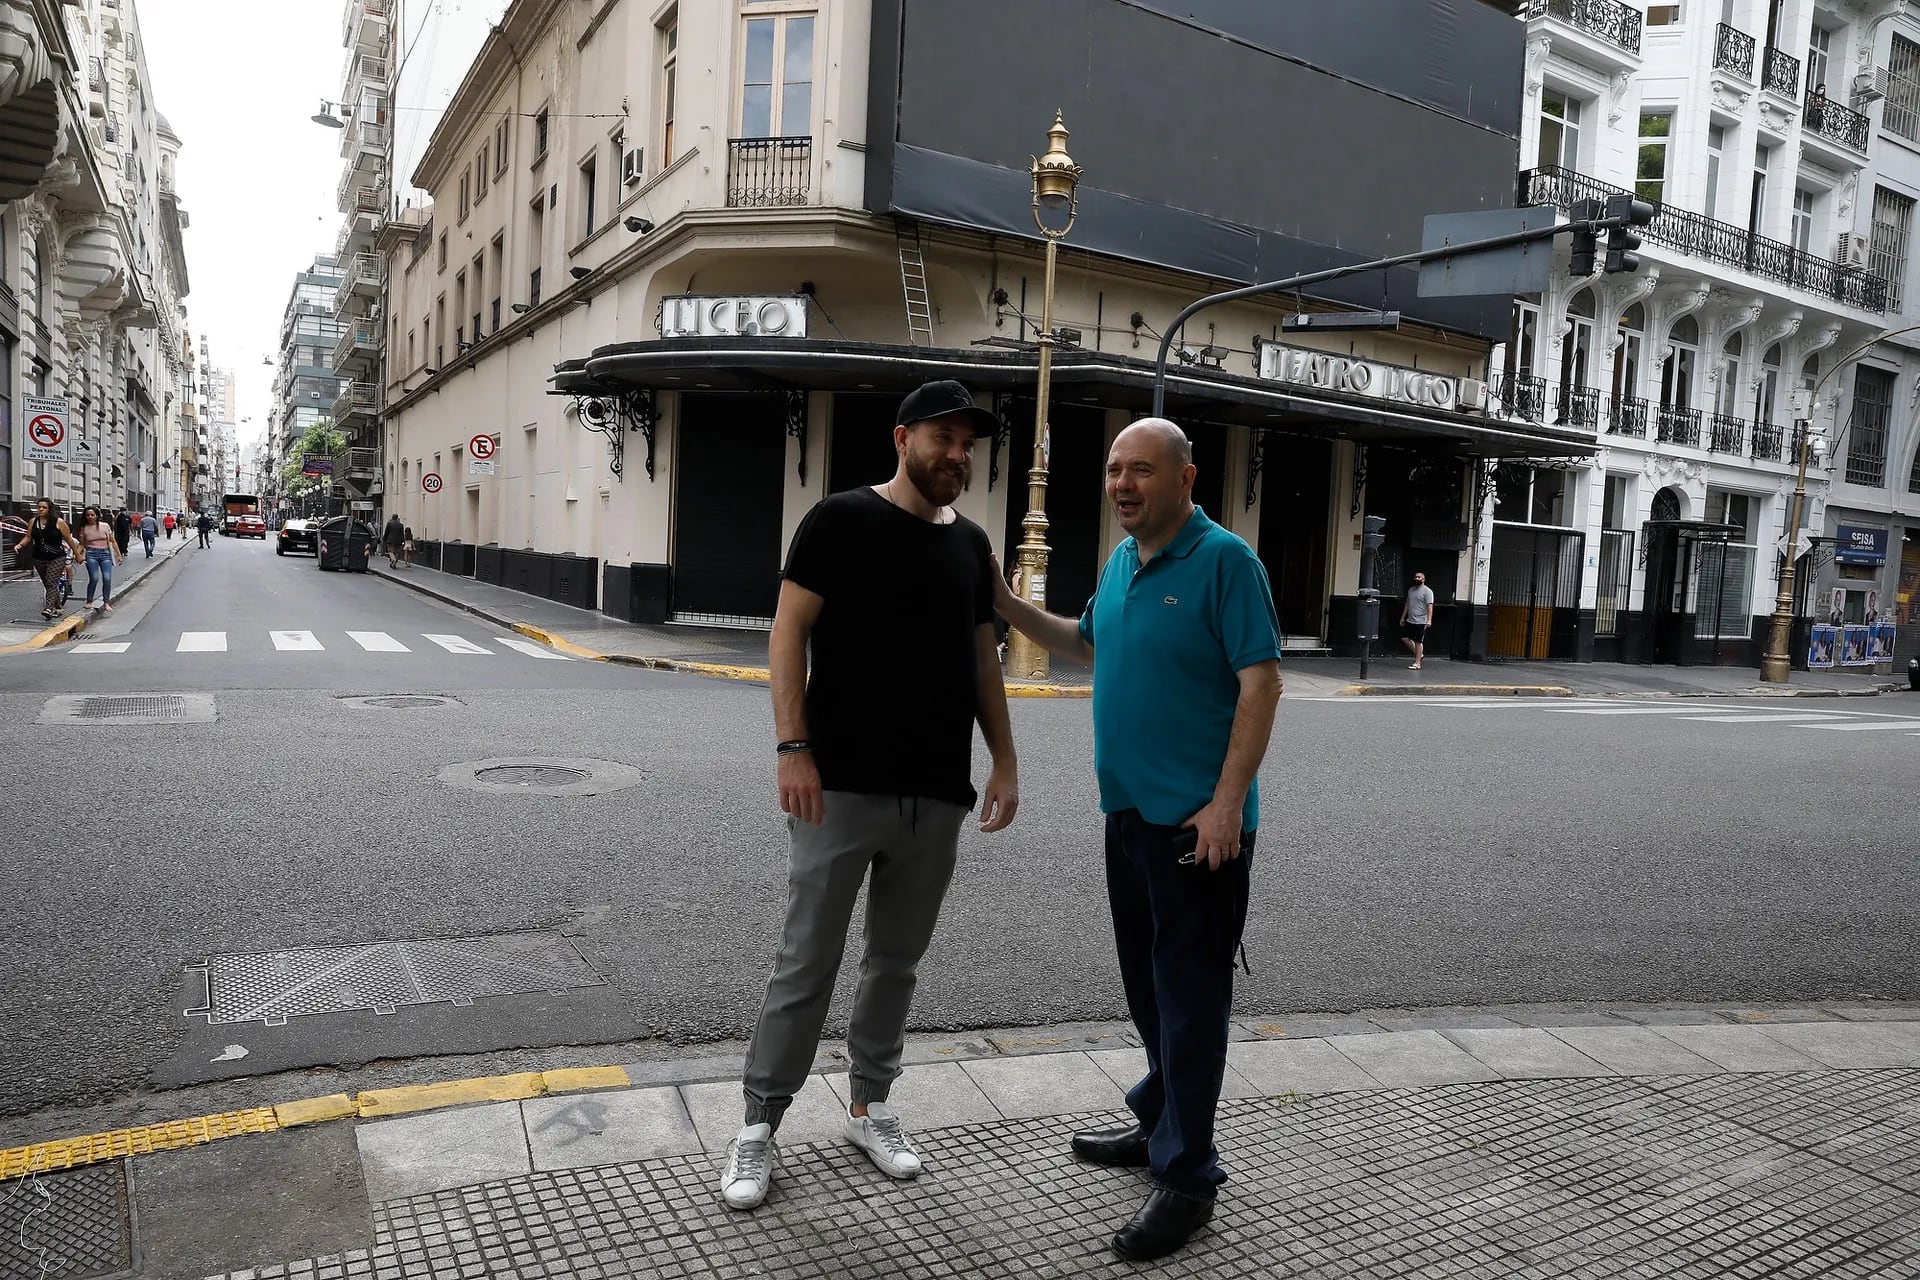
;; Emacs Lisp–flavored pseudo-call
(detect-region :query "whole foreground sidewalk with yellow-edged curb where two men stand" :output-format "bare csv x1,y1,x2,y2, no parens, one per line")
0,1004,1920,1280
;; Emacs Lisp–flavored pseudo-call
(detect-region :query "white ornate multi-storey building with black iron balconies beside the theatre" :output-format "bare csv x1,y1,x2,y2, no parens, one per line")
1512,0,1912,664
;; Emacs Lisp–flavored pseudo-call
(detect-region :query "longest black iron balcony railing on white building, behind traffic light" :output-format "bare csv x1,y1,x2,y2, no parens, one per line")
1521,167,1887,313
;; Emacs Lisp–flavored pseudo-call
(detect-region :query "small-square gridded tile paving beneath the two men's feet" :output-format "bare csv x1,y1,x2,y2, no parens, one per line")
206,1071,1920,1280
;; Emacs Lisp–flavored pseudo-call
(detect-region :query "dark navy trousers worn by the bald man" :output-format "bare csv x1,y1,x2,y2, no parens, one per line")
1106,810,1254,1199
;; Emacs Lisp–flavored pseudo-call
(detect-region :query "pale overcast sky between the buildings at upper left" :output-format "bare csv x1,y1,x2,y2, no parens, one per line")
138,0,505,458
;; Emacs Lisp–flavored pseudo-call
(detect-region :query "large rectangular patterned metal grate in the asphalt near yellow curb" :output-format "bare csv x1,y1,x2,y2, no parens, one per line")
186,933,605,1027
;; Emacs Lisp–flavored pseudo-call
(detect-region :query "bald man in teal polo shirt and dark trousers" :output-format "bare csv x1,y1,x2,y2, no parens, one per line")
996,418,1281,1261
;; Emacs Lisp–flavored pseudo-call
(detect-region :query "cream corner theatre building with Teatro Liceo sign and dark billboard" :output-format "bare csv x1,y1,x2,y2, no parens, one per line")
380,0,1594,649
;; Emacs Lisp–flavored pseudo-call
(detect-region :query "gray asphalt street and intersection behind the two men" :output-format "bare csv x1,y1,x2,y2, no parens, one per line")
0,539,1920,1115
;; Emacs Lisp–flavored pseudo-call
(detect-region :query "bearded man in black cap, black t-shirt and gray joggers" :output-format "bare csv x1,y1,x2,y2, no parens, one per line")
720,382,1020,1209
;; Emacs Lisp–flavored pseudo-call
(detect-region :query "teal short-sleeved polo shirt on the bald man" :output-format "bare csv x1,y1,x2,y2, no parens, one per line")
1079,507,1281,831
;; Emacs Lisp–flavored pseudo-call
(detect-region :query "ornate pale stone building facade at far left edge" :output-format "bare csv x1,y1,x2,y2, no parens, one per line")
0,0,194,510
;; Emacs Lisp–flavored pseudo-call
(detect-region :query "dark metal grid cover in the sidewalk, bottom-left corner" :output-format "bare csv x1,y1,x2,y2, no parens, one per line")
0,1159,132,1280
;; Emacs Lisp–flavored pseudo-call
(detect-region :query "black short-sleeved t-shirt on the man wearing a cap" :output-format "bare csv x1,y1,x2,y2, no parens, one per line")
785,486,993,806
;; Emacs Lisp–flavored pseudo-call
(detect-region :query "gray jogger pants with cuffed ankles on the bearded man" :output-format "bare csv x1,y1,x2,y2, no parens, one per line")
743,791,968,1128
